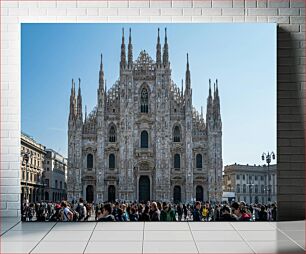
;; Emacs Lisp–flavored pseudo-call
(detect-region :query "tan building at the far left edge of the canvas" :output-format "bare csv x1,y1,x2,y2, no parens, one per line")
20,133,46,202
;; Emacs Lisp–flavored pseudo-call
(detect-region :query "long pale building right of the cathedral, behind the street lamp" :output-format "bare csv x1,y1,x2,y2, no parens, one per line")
223,163,277,203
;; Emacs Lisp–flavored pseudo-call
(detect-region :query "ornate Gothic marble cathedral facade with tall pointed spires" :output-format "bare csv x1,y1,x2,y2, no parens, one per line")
68,29,222,203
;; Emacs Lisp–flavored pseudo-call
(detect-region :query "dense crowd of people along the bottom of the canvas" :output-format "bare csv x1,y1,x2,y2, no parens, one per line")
22,198,277,222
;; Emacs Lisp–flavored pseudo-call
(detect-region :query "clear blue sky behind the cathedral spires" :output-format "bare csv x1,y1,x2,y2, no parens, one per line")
21,24,276,165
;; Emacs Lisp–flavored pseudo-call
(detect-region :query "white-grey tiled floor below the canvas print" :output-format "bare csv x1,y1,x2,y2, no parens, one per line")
0,218,305,253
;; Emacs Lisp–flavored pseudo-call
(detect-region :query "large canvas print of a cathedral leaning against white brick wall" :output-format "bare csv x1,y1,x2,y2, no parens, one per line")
20,24,277,221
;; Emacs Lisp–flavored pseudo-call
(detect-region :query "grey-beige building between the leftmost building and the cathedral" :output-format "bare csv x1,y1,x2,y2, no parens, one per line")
44,149,67,201
